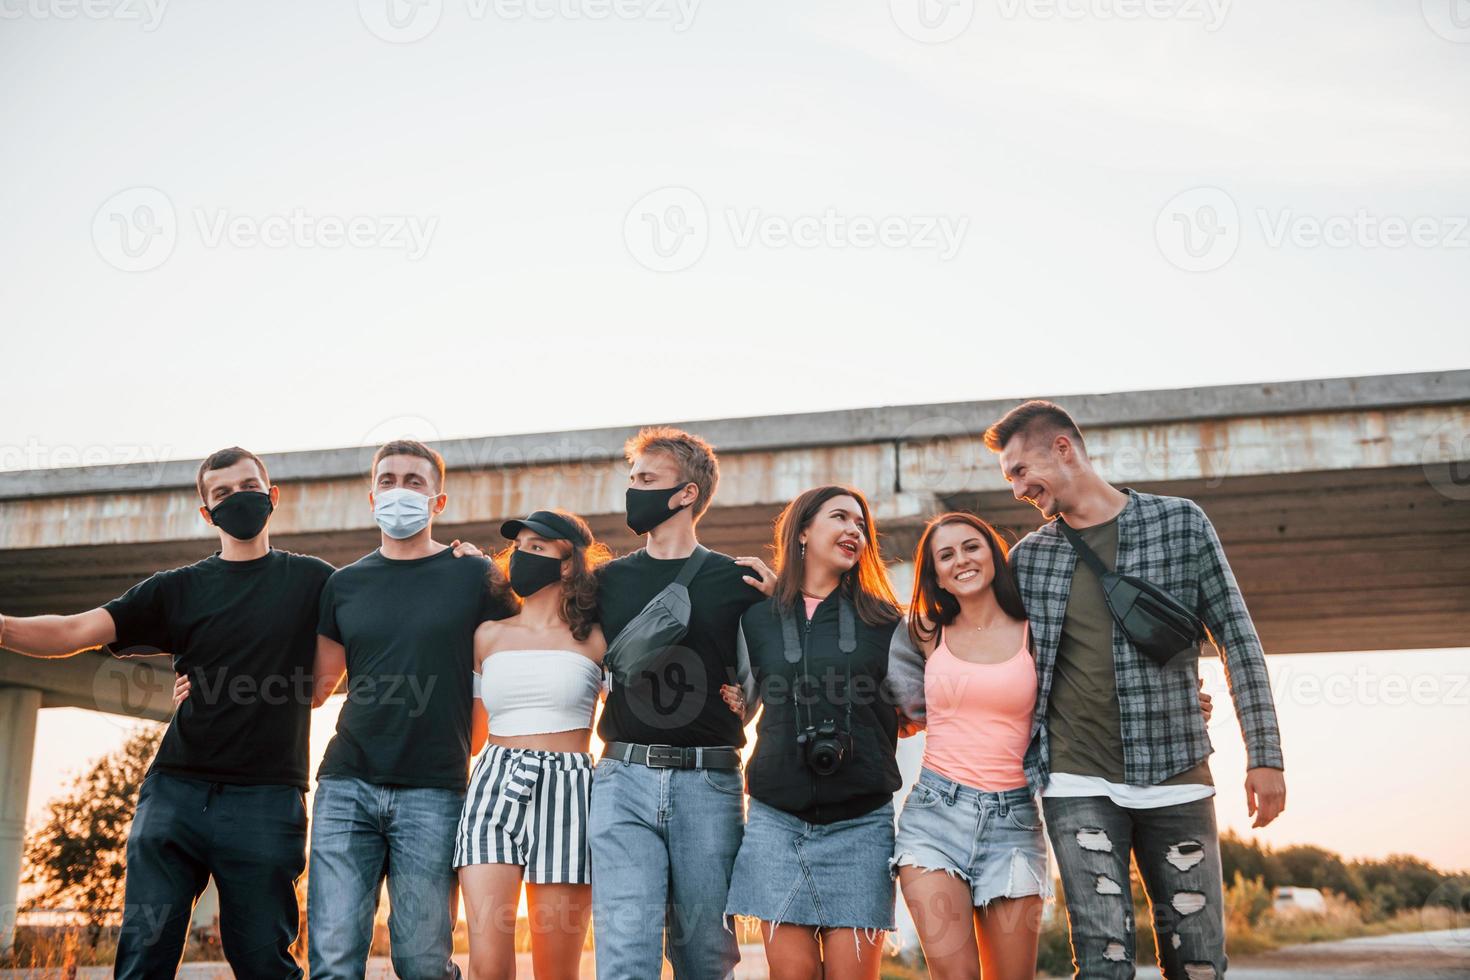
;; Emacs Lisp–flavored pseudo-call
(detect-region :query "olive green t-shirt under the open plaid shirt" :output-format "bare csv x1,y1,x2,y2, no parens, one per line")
1047,517,1214,786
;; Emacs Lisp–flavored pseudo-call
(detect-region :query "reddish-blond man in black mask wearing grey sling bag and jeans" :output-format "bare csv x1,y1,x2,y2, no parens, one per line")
588,428,775,980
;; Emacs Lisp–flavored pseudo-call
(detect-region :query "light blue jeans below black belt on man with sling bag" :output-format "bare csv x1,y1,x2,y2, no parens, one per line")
588,758,745,980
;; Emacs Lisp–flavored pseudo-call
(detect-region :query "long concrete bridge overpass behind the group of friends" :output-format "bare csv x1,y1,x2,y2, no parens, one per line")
0,370,1470,952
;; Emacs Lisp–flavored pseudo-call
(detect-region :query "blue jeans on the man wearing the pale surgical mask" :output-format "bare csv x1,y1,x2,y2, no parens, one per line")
306,776,465,980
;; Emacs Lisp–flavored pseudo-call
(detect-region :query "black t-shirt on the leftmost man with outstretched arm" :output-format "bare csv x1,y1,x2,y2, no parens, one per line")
103,551,332,789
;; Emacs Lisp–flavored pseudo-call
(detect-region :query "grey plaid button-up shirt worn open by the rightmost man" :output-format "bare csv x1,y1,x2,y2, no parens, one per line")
1010,491,1282,792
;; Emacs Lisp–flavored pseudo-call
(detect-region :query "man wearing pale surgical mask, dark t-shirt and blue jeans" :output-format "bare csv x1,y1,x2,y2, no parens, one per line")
307,439,512,979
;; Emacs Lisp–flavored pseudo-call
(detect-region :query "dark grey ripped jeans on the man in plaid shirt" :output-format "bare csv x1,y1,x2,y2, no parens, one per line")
1042,796,1226,980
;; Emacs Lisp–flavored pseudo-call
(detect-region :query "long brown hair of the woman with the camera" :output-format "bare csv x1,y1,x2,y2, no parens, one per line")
775,486,903,626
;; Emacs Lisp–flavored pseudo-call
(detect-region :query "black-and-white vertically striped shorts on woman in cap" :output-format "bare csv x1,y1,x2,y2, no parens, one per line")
454,745,592,884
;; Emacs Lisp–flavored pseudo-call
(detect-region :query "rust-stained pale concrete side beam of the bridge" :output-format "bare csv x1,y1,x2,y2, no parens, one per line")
0,399,1470,551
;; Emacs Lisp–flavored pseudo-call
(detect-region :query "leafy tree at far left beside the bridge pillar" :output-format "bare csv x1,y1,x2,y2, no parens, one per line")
24,724,163,946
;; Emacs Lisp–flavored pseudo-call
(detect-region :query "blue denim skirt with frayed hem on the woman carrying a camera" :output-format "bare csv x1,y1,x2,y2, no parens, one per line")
725,799,894,930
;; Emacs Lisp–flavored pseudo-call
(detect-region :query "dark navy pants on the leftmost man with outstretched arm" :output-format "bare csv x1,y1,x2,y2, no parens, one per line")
115,773,306,980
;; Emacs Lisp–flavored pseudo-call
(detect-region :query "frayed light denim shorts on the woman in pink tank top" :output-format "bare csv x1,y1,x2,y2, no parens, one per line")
892,768,1051,908
